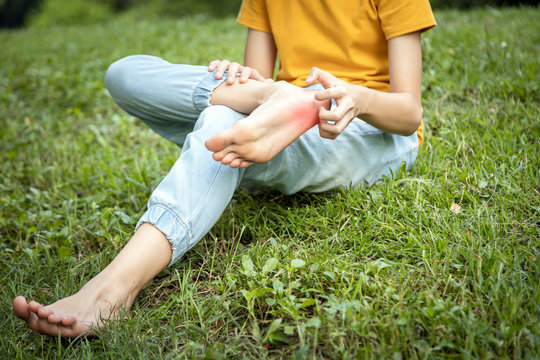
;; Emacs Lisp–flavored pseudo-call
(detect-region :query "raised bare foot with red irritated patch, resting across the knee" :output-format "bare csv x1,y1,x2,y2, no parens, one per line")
205,83,330,167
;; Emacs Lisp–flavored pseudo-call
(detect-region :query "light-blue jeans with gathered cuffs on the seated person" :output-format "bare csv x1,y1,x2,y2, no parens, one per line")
105,55,418,264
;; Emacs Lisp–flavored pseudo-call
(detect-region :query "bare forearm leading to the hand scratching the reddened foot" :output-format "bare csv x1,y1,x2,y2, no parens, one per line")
355,86,422,136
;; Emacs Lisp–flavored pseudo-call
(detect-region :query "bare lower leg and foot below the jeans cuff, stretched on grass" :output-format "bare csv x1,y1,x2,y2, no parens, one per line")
13,224,172,338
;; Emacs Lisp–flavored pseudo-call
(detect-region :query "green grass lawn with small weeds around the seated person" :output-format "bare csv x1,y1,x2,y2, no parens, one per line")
0,8,540,359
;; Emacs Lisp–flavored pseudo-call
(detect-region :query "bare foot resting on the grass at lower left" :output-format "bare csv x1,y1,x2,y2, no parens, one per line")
13,279,131,338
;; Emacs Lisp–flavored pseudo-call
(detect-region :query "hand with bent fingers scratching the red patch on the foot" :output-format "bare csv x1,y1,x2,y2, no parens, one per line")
306,67,365,139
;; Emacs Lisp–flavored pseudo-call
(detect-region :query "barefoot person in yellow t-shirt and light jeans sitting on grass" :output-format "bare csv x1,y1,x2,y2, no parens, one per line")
13,0,435,337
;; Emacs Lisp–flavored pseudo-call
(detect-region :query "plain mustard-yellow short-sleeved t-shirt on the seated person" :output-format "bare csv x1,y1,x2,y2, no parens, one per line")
238,0,436,142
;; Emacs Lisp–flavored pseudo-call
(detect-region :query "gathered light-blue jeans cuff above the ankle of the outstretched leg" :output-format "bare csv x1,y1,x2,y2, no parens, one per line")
135,204,194,266
